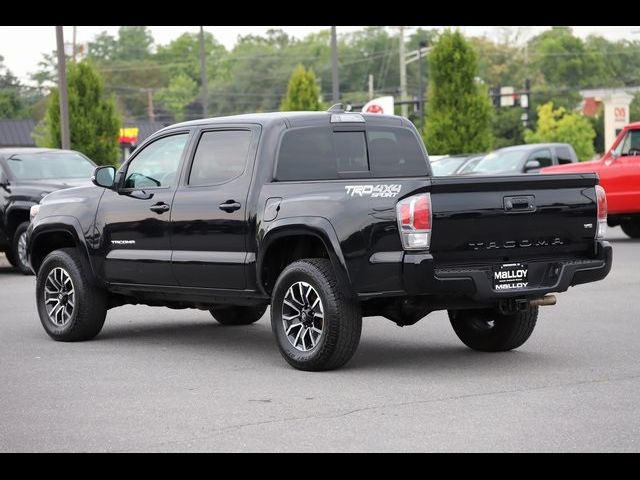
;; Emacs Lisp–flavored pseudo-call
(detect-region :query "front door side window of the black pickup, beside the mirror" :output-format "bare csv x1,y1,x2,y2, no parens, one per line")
124,133,189,190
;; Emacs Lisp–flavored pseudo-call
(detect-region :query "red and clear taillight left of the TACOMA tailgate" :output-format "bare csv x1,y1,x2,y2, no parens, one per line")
396,193,431,250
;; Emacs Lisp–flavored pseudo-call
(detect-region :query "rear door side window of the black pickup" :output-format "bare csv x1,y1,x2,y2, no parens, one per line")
189,130,251,185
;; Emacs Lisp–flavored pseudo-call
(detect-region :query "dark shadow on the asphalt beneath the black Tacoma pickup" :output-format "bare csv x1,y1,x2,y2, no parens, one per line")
96,318,550,375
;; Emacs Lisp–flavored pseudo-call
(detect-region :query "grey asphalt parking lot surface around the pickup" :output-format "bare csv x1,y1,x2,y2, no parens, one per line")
0,229,640,452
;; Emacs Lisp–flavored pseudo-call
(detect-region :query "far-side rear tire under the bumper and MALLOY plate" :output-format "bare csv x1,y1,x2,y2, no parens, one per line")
449,307,538,352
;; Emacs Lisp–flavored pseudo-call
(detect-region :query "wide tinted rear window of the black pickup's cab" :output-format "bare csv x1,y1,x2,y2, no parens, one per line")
276,127,428,181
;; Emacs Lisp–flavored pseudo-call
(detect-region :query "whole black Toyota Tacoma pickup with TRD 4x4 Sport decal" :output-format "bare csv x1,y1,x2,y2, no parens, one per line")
28,109,612,370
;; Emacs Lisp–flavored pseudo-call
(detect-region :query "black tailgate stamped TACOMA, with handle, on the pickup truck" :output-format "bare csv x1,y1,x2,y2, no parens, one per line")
431,174,598,266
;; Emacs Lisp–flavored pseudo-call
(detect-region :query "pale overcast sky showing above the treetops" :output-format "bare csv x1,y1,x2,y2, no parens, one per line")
0,26,640,83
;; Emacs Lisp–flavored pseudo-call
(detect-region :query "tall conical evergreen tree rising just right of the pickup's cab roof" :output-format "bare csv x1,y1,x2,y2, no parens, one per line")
425,31,493,154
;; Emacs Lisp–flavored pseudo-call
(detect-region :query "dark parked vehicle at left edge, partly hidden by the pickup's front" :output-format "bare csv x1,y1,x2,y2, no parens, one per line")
0,148,95,274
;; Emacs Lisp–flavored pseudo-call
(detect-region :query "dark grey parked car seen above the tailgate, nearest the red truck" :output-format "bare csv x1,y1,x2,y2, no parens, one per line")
468,143,578,175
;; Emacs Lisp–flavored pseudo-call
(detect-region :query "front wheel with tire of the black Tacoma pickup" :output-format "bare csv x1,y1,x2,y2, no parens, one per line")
36,248,108,342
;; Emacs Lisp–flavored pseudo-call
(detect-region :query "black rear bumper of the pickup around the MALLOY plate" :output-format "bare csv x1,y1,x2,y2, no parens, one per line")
403,242,613,301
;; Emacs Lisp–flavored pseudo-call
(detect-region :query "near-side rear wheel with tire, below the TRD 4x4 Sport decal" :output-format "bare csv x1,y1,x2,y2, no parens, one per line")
271,259,362,371
